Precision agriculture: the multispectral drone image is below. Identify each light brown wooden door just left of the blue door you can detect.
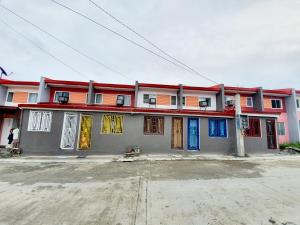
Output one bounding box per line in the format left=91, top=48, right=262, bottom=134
left=172, top=117, right=183, bottom=149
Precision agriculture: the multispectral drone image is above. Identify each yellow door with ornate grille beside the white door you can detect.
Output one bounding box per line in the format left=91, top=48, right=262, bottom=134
left=78, top=115, right=93, bottom=150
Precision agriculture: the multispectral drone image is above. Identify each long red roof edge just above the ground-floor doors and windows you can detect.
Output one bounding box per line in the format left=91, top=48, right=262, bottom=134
left=19, top=103, right=234, bottom=117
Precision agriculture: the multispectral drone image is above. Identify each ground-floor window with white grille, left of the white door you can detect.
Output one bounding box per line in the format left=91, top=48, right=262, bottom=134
left=28, top=111, right=52, bottom=132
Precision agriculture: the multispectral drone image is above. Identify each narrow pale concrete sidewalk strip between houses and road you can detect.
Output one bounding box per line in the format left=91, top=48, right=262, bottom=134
left=0, top=153, right=300, bottom=163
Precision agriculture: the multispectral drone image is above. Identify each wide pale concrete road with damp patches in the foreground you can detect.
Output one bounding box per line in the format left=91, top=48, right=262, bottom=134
left=0, top=159, right=300, bottom=225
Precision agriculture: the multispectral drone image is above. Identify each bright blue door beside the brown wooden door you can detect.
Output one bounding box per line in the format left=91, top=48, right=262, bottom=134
left=188, top=118, right=199, bottom=150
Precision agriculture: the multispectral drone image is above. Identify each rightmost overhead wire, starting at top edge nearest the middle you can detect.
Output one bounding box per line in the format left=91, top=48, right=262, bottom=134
left=88, top=0, right=217, bottom=84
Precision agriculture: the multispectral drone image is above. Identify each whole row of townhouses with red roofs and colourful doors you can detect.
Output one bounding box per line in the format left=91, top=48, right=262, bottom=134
left=0, top=77, right=300, bottom=155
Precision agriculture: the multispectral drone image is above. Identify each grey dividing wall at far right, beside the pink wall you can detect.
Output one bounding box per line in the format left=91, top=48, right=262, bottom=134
left=286, top=89, right=300, bottom=142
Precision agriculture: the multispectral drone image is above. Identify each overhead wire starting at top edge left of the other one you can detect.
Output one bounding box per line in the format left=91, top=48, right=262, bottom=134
left=50, top=0, right=217, bottom=83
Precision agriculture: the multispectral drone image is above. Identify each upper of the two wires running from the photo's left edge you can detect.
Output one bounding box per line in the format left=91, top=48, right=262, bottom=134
left=0, top=4, right=130, bottom=80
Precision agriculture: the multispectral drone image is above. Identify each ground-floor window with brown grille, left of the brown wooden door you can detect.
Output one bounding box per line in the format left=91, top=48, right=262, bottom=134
left=144, top=116, right=164, bottom=135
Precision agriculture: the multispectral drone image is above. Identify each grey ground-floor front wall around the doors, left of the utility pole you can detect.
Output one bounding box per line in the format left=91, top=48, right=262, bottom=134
left=21, top=110, right=235, bottom=155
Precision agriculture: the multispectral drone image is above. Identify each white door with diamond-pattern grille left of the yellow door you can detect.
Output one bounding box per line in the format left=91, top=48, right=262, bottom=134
left=60, top=113, right=78, bottom=149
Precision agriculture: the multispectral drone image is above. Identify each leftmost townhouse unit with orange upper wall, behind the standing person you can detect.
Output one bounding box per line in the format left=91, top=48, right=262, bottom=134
left=0, top=79, right=39, bottom=146
